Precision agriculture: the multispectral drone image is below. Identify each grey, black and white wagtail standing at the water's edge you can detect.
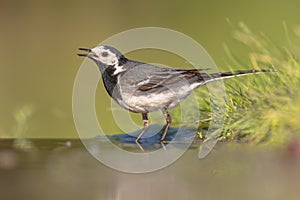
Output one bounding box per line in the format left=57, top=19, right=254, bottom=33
left=78, top=46, right=271, bottom=143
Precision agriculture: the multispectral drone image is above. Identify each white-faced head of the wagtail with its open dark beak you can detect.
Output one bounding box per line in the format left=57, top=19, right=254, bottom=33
left=77, top=46, right=125, bottom=66
